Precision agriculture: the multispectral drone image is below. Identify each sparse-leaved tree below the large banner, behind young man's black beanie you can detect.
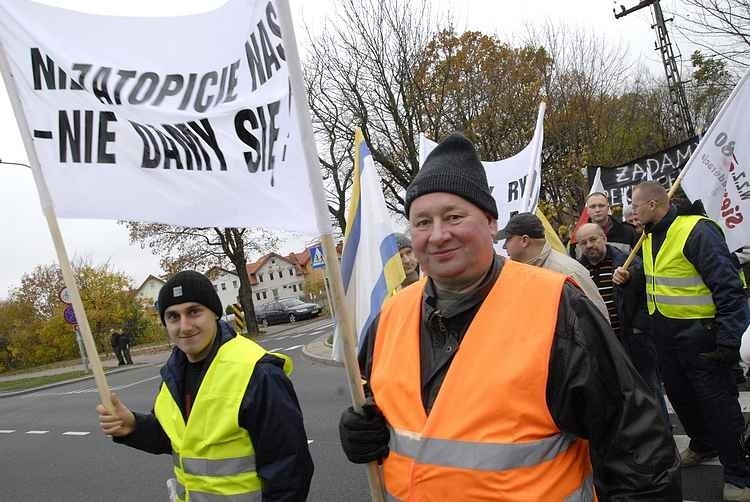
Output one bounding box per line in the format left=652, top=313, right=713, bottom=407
left=124, top=222, right=278, bottom=335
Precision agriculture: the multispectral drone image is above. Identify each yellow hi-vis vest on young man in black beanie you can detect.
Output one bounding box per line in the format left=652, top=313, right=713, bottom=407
left=154, top=334, right=292, bottom=502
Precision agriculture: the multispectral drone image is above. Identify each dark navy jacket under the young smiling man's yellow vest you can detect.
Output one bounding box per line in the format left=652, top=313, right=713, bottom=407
left=113, top=321, right=313, bottom=502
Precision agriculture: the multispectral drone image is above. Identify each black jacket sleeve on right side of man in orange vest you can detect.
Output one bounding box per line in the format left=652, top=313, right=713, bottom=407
left=547, top=285, right=682, bottom=502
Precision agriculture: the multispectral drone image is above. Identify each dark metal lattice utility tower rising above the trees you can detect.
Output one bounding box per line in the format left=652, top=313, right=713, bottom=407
left=614, top=0, right=695, bottom=137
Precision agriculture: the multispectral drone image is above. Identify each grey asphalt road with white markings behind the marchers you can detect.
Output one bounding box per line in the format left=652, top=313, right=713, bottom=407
left=0, top=320, right=750, bottom=502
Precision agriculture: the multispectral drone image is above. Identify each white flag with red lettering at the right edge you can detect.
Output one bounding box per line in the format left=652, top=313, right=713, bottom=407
left=682, top=68, right=750, bottom=251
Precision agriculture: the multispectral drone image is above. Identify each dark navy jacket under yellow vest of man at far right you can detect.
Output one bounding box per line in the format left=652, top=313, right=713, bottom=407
left=645, top=204, right=750, bottom=347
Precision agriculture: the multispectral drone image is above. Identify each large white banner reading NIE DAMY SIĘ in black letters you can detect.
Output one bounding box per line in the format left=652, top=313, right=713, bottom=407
left=0, top=0, right=318, bottom=233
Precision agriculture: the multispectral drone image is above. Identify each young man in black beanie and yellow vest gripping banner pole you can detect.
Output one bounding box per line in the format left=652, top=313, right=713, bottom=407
left=97, top=271, right=313, bottom=502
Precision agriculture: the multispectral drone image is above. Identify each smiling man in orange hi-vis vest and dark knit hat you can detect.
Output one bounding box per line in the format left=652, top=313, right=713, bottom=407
left=339, top=134, right=682, bottom=502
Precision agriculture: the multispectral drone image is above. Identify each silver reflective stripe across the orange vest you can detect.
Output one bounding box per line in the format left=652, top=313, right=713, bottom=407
left=389, top=429, right=575, bottom=471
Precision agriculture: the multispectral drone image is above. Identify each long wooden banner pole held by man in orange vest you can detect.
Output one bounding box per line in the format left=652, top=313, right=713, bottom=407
left=276, top=0, right=384, bottom=502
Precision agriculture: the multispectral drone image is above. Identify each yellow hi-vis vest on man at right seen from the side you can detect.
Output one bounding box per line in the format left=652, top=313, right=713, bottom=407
left=643, top=215, right=716, bottom=319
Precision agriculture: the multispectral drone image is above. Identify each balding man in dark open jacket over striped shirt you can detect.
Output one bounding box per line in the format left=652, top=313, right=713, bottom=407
left=576, top=223, right=669, bottom=423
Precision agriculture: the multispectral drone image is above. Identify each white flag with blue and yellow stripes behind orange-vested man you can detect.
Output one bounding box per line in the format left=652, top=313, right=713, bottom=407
left=334, top=128, right=406, bottom=355
